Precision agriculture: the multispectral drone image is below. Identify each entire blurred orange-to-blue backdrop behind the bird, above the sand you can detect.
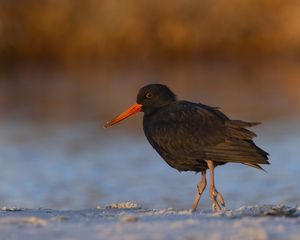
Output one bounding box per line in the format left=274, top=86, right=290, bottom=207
left=0, top=0, right=300, bottom=209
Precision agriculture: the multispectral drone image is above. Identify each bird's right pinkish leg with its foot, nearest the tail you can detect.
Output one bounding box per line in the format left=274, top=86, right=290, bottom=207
left=206, top=160, right=225, bottom=211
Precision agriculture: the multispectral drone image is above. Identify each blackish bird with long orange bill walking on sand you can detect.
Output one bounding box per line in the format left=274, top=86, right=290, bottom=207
left=104, top=84, right=270, bottom=211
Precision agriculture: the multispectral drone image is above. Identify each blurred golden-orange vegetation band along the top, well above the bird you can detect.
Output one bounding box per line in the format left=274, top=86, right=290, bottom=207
left=0, top=0, right=300, bottom=64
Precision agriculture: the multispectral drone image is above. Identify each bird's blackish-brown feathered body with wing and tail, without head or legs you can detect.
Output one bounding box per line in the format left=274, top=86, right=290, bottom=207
left=143, top=101, right=269, bottom=172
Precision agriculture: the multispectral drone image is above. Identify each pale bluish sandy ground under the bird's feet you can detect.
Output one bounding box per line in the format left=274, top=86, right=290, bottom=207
left=0, top=202, right=300, bottom=240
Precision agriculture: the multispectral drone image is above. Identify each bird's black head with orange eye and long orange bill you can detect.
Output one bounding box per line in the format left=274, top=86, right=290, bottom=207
left=104, top=84, right=176, bottom=128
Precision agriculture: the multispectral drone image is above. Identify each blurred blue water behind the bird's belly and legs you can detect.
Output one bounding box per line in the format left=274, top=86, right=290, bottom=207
left=0, top=121, right=300, bottom=209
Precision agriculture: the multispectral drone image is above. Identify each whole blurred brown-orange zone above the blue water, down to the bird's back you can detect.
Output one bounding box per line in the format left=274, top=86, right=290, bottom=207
left=0, top=0, right=300, bottom=120
